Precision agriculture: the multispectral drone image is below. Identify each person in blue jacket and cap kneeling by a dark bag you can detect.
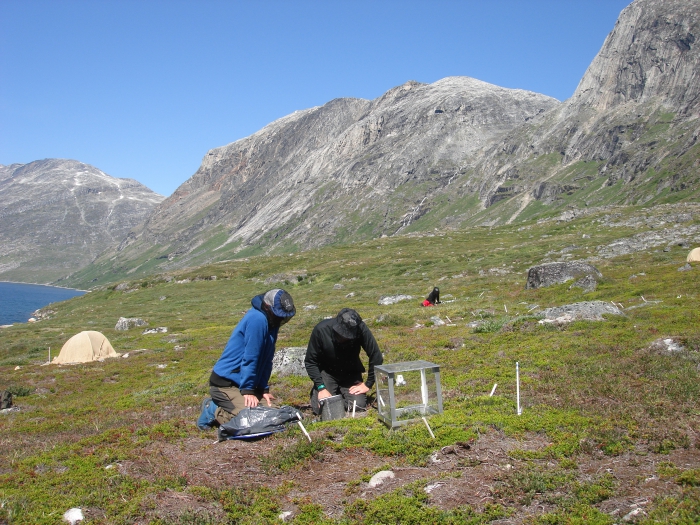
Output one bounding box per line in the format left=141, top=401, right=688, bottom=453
left=197, top=288, right=296, bottom=430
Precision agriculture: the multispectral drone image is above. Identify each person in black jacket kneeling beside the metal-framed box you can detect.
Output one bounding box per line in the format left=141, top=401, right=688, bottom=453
left=304, top=308, right=384, bottom=415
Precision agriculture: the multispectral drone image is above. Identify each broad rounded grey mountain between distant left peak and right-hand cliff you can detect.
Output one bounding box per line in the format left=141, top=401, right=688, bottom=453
left=115, top=77, right=558, bottom=265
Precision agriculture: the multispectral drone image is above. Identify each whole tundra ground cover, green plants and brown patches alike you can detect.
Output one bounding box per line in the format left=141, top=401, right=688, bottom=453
left=0, top=208, right=700, bottom=525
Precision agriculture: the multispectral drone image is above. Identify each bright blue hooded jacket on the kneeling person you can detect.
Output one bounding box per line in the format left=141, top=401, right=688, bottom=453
left=214, top=294, right=279, bottom=395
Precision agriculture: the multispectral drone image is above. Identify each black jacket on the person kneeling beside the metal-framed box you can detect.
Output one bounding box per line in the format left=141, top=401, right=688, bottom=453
left=304, top=319, right=384, bottom=388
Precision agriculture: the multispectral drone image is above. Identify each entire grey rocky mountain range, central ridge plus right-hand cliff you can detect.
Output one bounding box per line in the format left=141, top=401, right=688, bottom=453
left=71, top=0, right=700, bottom=279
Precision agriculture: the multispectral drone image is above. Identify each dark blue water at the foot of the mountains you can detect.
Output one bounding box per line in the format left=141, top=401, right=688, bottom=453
left=0, top=282, right=85, bottom=325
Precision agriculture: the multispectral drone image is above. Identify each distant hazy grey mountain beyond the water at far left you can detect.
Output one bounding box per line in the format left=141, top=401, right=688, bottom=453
left=0, top=159, right=163, bottom=283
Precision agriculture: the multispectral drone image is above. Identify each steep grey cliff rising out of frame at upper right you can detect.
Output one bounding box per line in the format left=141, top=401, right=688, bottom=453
left=463, top=0, right=700, bottom=223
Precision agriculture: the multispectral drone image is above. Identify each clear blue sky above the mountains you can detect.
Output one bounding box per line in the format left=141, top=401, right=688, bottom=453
left=0, top=0, right=629, bottom=196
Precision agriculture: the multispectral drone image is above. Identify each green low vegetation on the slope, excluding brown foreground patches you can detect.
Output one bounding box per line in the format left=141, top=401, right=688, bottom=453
left=0, top=204, right=700, bottom=524
